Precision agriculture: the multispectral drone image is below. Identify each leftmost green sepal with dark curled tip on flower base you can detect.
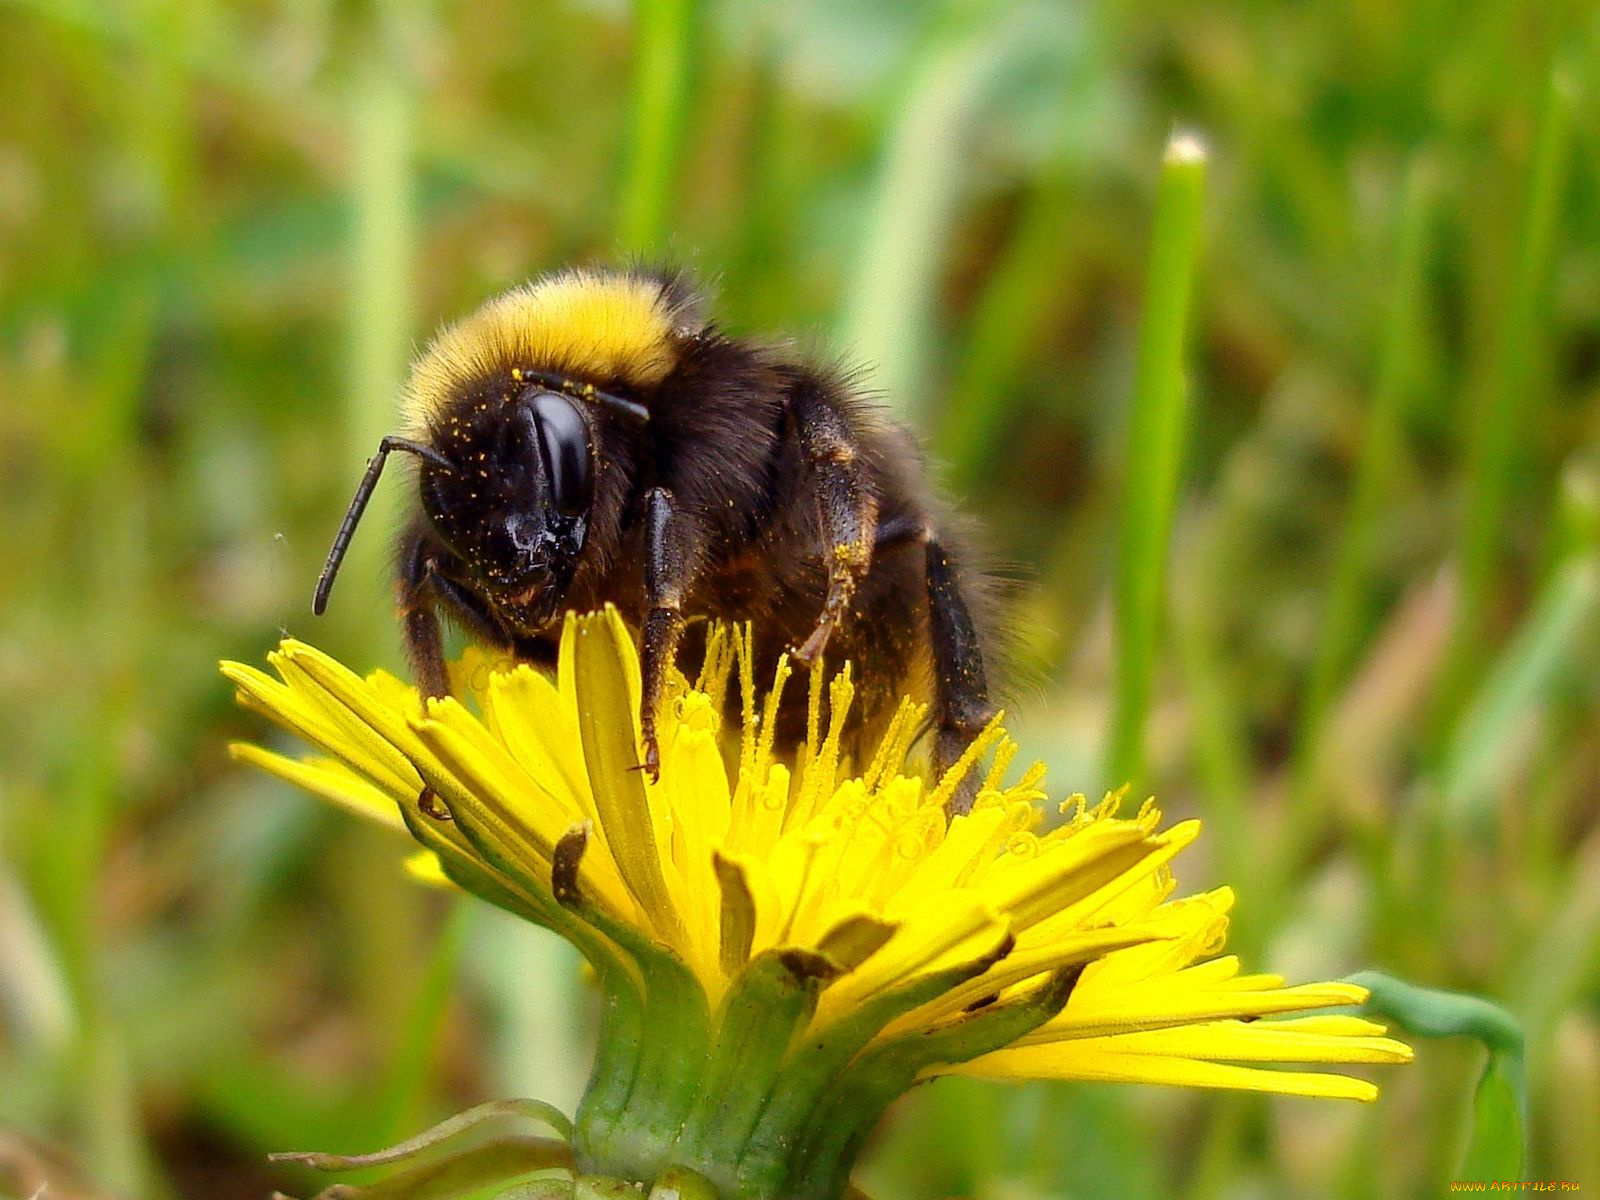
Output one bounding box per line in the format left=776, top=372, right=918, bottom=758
left=550, top=827, right=710, bottom=1179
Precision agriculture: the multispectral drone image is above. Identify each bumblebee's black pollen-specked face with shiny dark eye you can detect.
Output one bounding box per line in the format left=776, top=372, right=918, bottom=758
left=418, top=382, right=595, bottom=634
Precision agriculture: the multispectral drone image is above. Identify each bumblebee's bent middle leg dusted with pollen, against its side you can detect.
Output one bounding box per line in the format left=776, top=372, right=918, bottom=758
left=790, top=384, right=878, bottom=666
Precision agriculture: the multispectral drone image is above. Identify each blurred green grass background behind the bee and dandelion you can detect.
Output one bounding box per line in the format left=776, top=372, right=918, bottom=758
left=0, top=0, right=1600, bottom=1200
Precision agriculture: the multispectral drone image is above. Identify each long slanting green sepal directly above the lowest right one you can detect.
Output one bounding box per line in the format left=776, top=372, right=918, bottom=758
left=738, top=934, right=1014, bottom=1194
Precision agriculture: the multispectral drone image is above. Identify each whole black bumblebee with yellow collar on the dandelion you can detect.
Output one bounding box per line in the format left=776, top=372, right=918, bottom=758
left=312, top=270, right=994, bottom=808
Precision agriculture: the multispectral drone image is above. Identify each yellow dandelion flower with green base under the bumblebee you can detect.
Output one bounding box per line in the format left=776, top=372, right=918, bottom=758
left=224, top=610, right=1410, bottom=1200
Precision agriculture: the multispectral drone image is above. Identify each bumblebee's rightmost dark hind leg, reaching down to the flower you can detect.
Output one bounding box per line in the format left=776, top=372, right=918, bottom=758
left=926, top=536, right=995, bottom=816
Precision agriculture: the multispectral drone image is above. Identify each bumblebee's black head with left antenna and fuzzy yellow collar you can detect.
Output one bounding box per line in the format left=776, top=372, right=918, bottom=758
left=312, top=270, right=681, bottom=634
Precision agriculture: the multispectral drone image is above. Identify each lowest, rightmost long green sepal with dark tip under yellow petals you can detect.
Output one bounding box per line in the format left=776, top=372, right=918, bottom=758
left=781, top=965, right=1083, bottom=1200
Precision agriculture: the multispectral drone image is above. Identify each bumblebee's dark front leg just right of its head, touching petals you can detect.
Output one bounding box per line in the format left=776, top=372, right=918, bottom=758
left=638, top=488, right=706, bottom=779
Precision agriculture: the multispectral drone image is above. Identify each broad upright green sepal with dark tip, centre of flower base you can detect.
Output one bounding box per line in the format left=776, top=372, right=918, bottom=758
left=678, top=949, right=840, bottom=1182
